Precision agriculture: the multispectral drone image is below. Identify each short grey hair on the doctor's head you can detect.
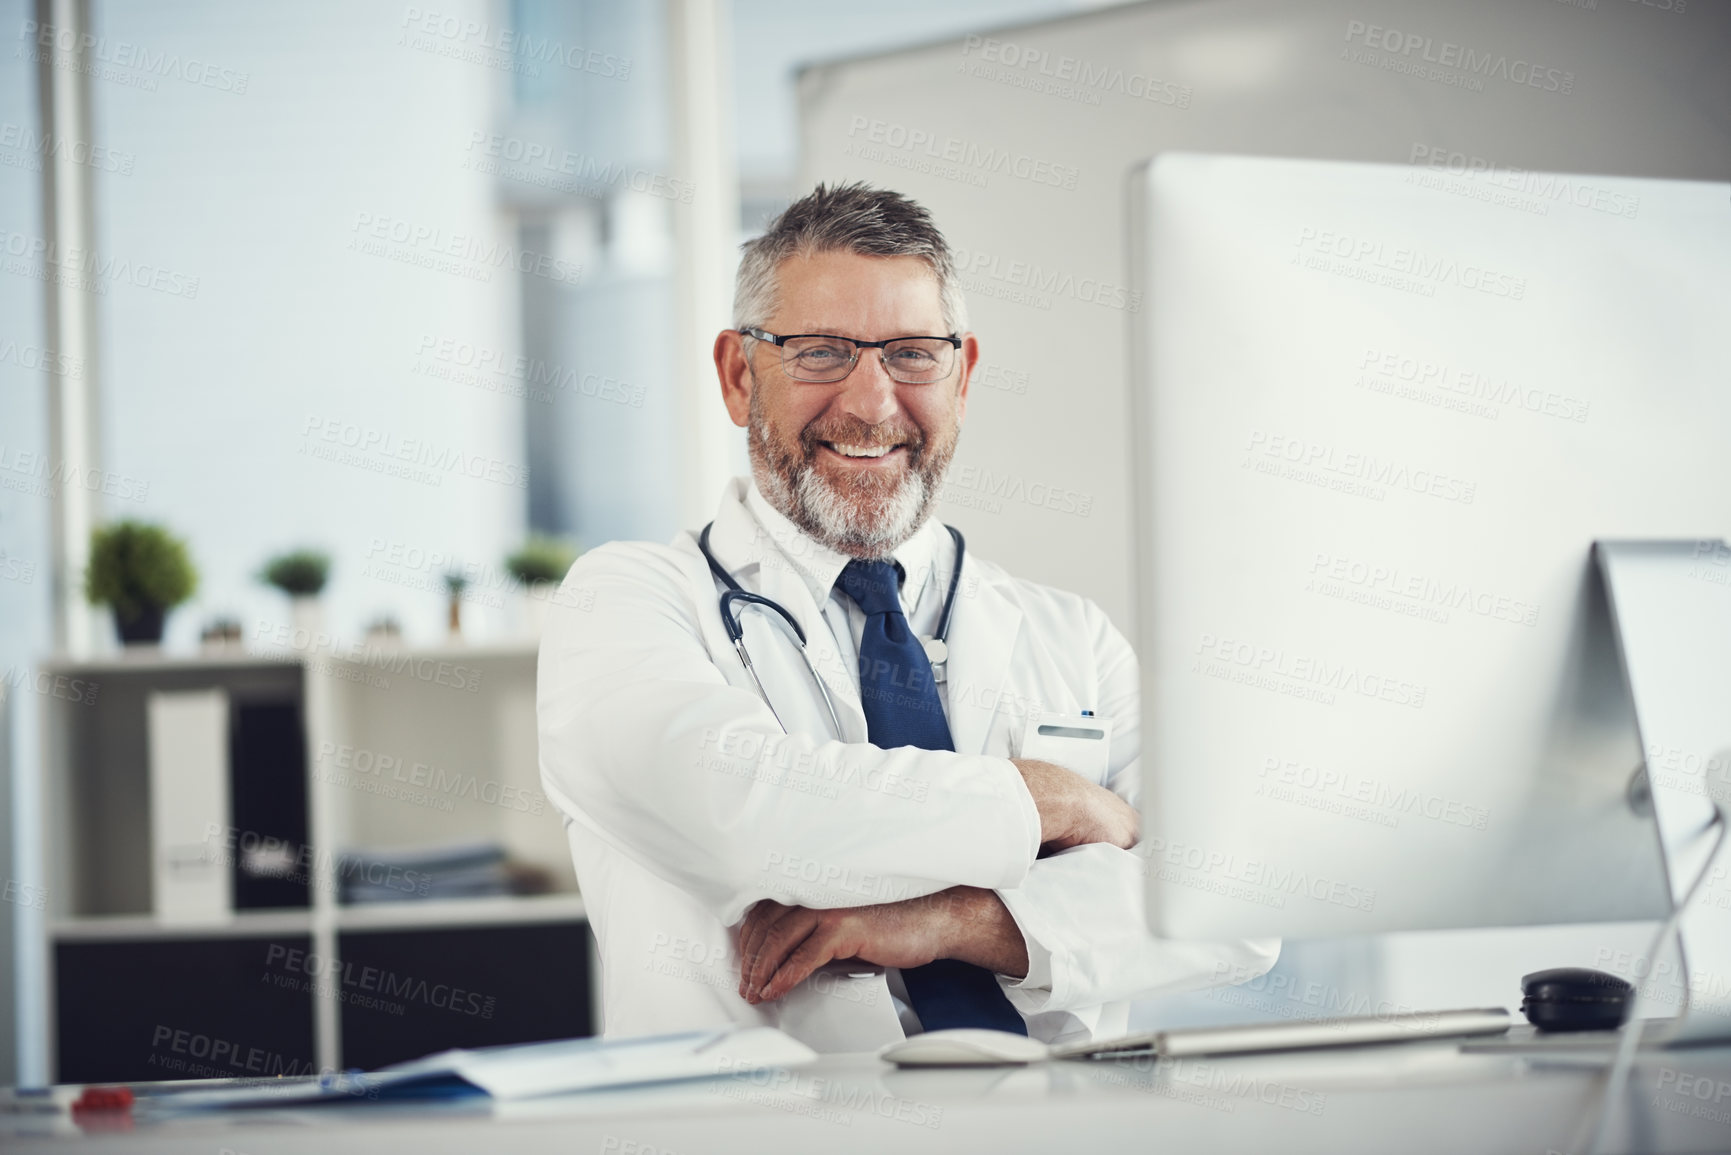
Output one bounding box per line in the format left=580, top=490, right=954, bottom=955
left=734, top=182, right=968, bottom=336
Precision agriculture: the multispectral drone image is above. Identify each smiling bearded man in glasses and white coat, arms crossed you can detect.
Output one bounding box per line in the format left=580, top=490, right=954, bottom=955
left=538, top=185, right=1277, bottom=1051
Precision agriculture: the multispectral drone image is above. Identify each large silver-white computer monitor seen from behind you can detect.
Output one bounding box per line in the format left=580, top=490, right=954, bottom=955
left=1130, top=154, right=1731, bottom=939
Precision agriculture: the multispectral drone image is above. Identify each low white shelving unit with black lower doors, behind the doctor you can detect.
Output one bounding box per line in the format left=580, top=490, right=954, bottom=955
left=28, top=641, right=592, bottom=1070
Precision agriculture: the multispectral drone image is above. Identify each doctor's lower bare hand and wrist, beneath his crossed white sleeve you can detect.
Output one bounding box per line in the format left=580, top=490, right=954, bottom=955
left=739, top=893, right=1024, bottom=1004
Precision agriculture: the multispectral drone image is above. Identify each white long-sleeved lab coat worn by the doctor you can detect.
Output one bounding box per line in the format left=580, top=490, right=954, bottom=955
left=537, top=478, right=1277, bottom=1051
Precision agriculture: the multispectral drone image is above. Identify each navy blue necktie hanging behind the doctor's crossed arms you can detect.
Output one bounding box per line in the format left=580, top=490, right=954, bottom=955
left=836, top=561, right=1028, bottom=1036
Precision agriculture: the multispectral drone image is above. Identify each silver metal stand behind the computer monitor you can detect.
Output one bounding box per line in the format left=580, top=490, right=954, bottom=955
left=1593, top=540, right=1731, bottom=1044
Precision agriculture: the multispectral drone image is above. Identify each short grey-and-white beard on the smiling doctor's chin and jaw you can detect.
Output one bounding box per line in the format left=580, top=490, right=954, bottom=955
left=748, top=379, right=956, bottom=561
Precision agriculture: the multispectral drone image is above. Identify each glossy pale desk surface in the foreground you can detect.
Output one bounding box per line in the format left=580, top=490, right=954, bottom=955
left=0, top=1042, right=1731, bottom=1155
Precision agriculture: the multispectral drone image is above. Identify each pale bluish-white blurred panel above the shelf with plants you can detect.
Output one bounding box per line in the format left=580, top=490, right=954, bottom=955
left=93, top=0, right=526, bottom=648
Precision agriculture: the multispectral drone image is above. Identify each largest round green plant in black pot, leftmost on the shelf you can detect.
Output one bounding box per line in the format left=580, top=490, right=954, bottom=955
left=85, top=521, right=199, bottom=646
